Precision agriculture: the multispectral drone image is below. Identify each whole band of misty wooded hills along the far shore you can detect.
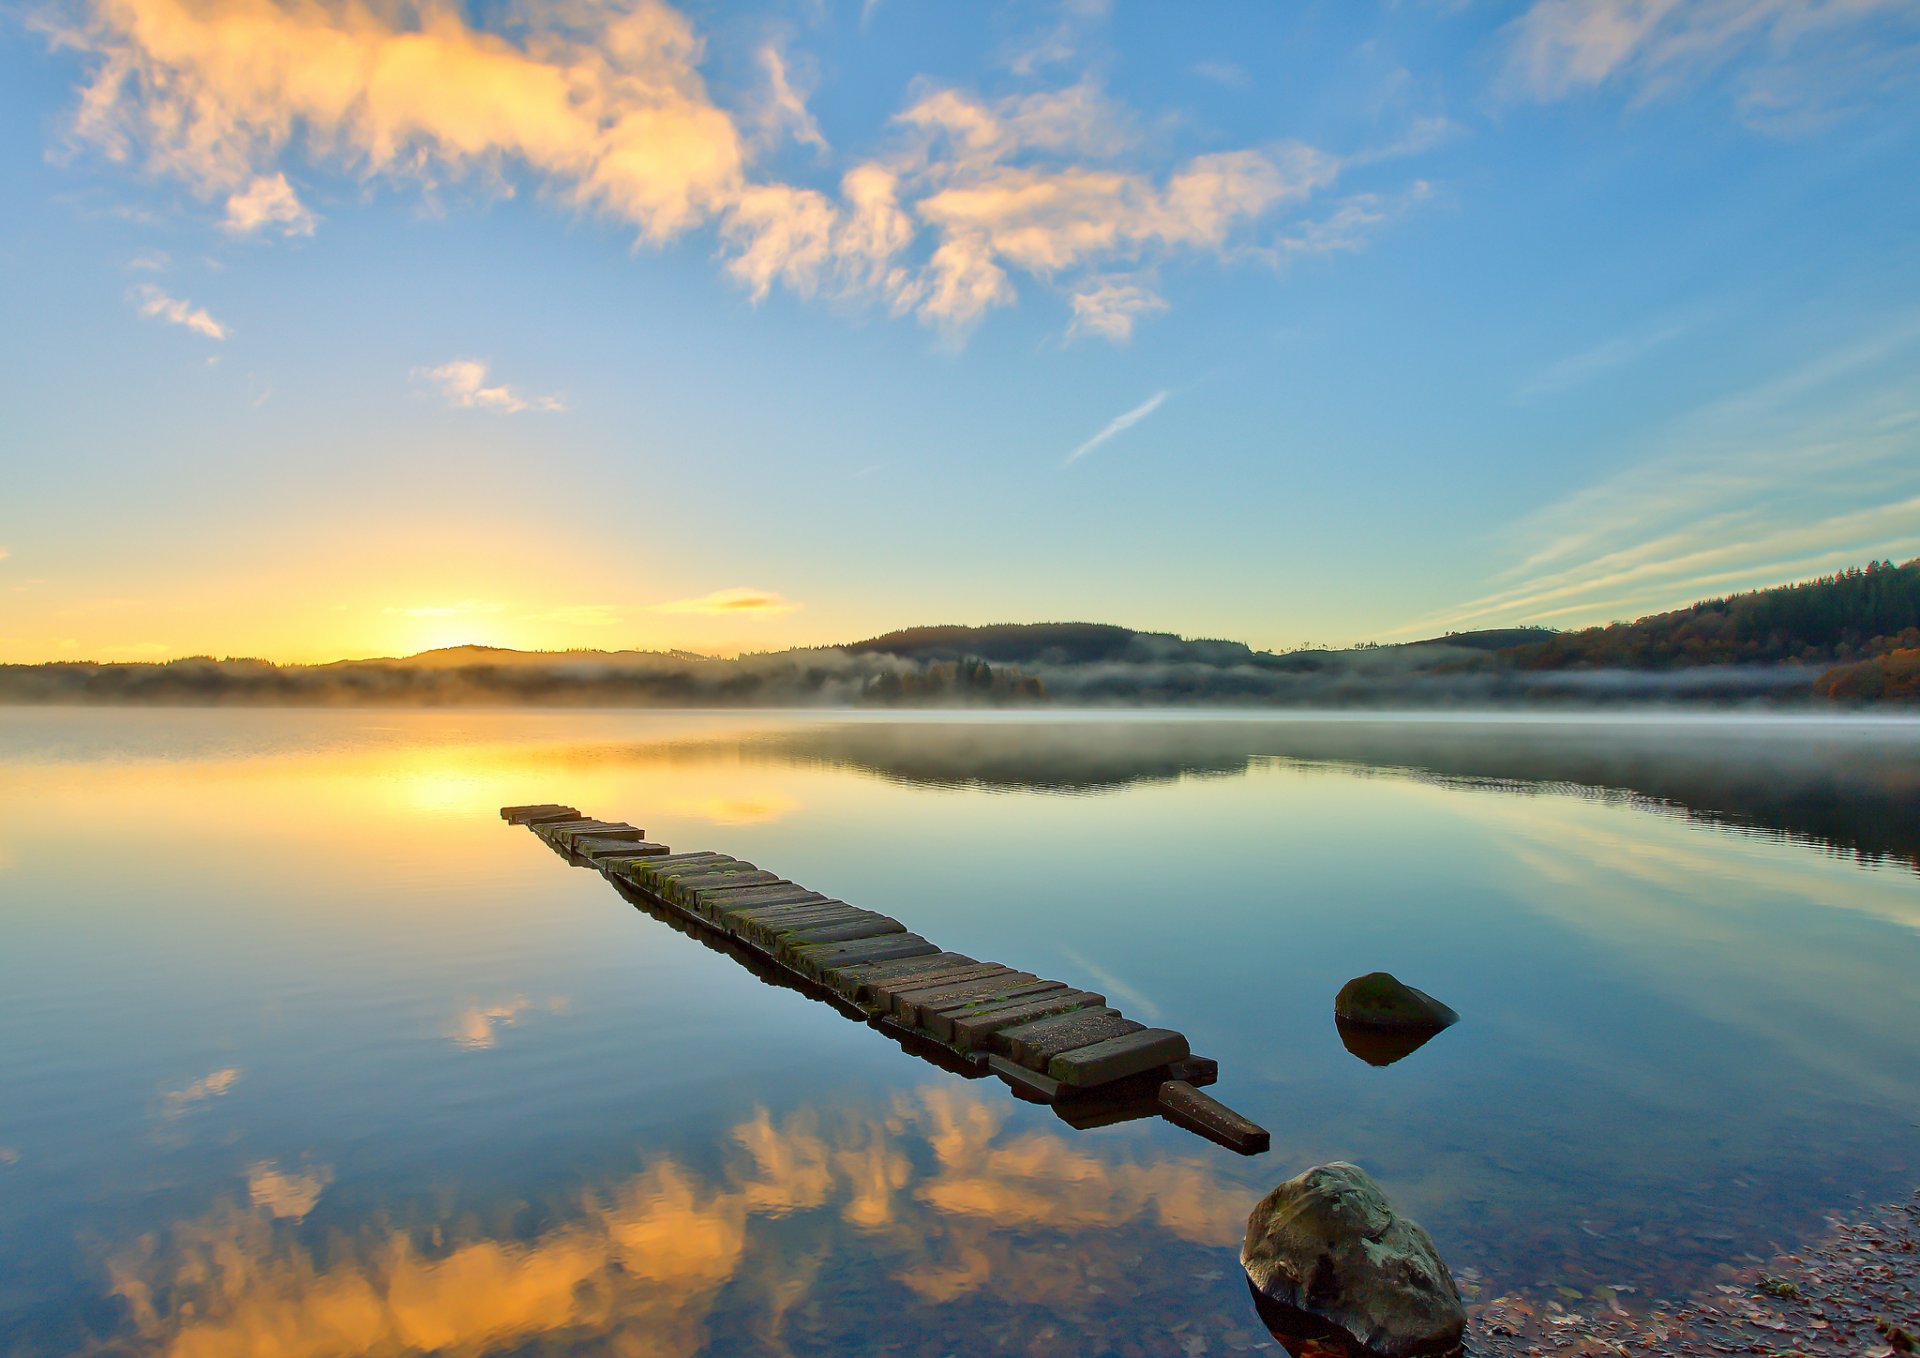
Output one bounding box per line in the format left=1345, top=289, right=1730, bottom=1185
left=0, top=561, right=1920, bottom=707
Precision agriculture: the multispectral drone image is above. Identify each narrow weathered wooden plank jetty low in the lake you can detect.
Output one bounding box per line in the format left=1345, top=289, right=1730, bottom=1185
left=499, top=805, right=1269, bottom=1154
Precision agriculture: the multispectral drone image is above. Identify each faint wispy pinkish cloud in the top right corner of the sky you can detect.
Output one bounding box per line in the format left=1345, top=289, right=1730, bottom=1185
left=1503, top=0, right=1920, bottom=125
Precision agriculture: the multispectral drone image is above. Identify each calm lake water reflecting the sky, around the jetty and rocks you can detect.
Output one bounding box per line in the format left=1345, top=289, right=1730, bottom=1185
left=0, top=711, right=1920, bottom=1358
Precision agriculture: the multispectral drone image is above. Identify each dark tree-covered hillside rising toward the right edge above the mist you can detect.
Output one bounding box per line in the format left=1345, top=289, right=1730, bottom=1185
left=1500, top=559, right=1920, bottom=670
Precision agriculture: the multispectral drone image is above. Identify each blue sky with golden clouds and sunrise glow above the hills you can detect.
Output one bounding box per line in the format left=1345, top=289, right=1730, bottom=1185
left=0, top=0, right=1920, bottom=661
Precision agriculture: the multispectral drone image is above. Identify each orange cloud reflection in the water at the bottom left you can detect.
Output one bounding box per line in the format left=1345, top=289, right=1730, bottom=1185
left=111, top=1087, right=1252, bottom=1358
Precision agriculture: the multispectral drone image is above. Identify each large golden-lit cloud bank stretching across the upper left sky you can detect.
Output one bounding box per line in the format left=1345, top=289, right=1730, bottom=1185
left=56, top=0, right=1413, bottom=339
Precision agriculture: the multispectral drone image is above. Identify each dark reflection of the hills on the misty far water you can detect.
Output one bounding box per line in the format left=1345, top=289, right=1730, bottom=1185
left=737, top=716, right=1920, bottom=866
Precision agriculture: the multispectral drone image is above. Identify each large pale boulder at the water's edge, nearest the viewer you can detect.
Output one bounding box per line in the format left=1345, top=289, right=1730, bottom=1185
left=1240, top=1162, right=1467, bottom=1358
